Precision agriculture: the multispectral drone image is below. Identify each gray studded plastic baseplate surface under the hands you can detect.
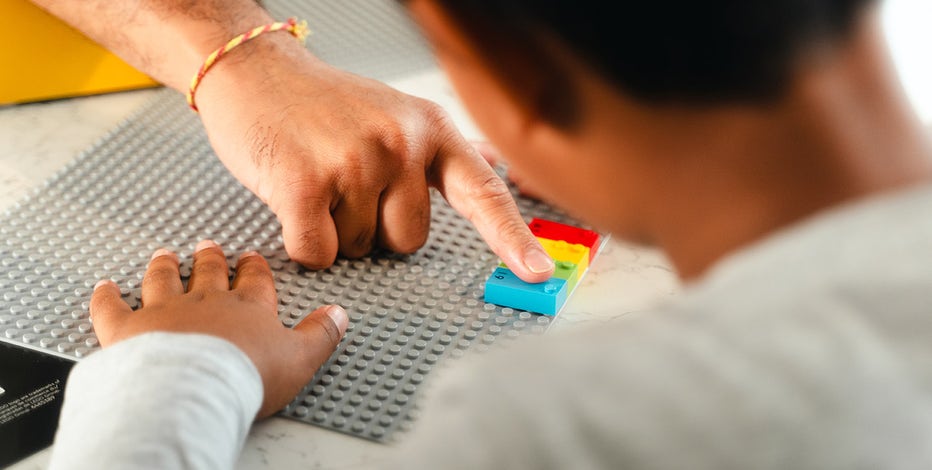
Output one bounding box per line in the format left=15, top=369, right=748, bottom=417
left=0, top=1, right=596, bottom=441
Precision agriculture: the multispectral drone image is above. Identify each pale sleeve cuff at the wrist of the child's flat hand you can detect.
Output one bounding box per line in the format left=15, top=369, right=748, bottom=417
left=49, top=333, right=263, bottom=470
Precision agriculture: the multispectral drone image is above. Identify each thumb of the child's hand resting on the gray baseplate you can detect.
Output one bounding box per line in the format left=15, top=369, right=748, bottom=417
left=294, top=305, right=349, bottom=370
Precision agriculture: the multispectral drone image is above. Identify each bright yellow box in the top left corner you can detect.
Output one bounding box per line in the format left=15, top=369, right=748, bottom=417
left=0, top=0, right=158, bottom=105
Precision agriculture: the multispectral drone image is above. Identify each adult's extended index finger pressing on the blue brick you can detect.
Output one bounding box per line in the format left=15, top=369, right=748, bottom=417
left=431, top=136, right=554, bottom=282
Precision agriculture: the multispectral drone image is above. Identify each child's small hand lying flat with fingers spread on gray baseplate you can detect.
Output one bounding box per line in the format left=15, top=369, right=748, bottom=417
left=90, top=241, right=349, bottom=417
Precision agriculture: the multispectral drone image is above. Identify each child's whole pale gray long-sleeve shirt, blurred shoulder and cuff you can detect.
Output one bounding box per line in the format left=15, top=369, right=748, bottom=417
left=52, top=187, right=932, bottom=469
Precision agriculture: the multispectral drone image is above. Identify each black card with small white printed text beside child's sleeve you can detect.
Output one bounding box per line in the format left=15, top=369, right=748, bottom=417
left=0, top=342, right=75, bottom=467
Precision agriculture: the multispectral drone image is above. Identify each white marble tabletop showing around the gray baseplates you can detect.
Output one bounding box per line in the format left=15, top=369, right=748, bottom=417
left=0, top=72, right=679, bottom=470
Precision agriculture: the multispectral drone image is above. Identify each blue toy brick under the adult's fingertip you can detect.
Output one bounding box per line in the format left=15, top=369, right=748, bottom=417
left=485, top=267, right=569, bottom=315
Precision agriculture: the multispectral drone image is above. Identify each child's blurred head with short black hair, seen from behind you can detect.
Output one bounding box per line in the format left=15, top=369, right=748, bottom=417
left=407, top=0, right=912, bottom=278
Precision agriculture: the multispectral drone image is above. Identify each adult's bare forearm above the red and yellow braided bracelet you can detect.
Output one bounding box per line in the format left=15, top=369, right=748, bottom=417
left=33, top=0, right=274, bottom=91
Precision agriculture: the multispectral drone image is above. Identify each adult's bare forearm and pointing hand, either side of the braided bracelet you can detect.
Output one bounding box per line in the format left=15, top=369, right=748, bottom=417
left=27, top=0, right=553, bottom=282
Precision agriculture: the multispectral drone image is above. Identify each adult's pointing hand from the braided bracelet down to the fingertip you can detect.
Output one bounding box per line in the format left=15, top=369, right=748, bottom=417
left=197, top=34, right=553, bottom=282
